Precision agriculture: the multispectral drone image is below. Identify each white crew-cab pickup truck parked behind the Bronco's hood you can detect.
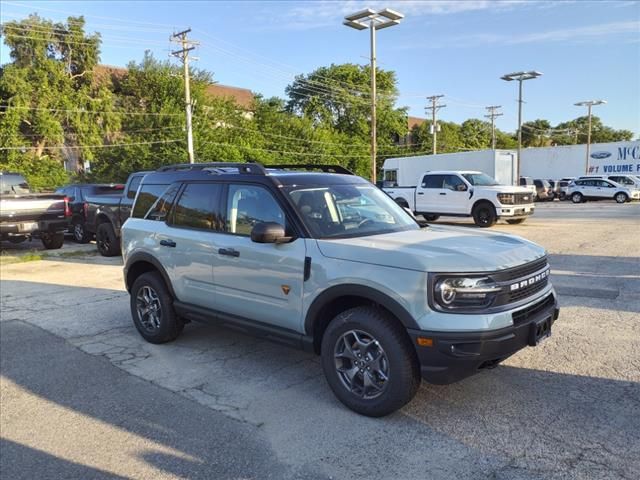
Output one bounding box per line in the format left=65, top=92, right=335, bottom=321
left=383, top=171, right=535, bottom=227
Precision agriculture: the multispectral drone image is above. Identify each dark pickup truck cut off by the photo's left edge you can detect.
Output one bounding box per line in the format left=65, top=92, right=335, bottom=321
left=0, top=172, right=71, bottom=249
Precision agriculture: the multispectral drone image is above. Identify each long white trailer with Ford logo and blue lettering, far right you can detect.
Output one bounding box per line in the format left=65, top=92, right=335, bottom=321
left=520, top=141, right=640, bottom=179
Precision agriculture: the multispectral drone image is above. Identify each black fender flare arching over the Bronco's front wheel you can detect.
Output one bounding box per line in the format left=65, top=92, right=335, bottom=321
left=304, top=284, right=420, bottom=335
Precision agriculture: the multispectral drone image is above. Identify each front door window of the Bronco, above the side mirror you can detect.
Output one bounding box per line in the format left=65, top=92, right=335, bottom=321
left=226, top=185, right=289, bottom=236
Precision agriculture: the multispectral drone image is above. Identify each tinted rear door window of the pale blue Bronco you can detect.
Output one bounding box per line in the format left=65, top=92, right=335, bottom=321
left=170, top=183, right=224, bottom=230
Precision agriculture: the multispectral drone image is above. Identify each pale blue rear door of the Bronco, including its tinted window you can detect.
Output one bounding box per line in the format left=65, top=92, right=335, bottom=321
left=156, top=183, right=223, bottom=308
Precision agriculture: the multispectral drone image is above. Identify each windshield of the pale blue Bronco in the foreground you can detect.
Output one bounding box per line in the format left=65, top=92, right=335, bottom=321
left=288, top=185, right=420, bottom=238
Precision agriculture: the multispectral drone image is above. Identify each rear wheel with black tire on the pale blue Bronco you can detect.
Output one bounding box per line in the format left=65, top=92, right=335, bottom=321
left=129, top=272, right=184, bottom=343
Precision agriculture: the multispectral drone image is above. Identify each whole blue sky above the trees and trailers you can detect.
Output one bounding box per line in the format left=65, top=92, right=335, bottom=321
left=0, top=0, right=640, bottom=136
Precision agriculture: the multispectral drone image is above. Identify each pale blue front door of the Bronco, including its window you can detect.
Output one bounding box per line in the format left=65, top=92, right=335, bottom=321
left=213, top=184, right=306, bottom=331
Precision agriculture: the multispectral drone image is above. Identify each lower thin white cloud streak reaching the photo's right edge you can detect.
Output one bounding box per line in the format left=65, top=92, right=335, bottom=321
left=400, top=21, right=640, bottom=50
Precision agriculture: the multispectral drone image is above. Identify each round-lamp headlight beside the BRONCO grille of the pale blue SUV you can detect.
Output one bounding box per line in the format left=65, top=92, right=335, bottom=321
left=432, top=275, right=501, bottom=310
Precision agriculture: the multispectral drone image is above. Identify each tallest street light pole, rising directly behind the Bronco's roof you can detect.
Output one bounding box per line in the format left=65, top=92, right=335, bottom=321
left=342, top=8, right=404, bottom=183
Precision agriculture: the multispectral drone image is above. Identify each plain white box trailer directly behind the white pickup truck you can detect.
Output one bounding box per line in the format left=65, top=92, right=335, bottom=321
left=382, top=150, right=518, bottom=187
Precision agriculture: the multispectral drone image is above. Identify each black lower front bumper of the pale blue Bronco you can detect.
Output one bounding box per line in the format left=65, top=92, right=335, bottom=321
left=408, top=293, right=560, bottom=385
